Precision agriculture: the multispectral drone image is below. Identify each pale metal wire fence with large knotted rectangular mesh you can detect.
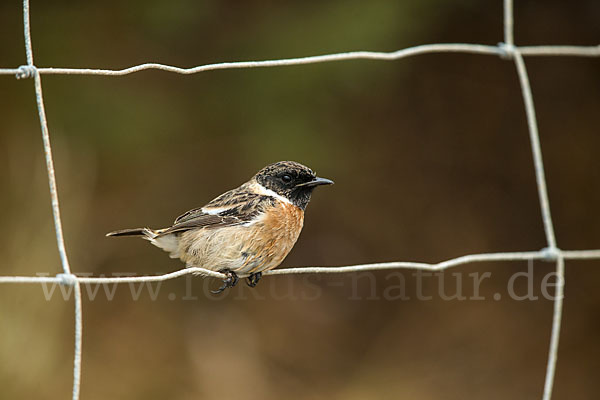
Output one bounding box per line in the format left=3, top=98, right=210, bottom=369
left=0, top=0, right=600, bottom=400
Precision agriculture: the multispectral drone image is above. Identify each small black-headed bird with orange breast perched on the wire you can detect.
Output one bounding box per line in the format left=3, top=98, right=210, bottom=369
left=106, top=161, right=333, bottom=293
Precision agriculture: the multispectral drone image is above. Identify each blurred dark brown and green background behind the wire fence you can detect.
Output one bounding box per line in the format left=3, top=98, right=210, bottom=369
left=0, top=0, right=600, bottom=400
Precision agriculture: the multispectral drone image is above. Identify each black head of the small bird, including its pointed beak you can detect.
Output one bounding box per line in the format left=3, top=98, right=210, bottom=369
left=255, top=161, right=333, bottom=210
